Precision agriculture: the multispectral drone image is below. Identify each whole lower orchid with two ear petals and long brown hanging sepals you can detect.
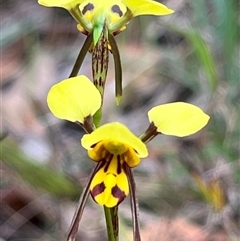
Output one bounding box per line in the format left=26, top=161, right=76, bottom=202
left=47, top=76, right=209, bottom=240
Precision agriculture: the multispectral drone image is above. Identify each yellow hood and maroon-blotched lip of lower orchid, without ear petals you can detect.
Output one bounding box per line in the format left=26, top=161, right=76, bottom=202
left=81, top=122, right=148, bottom=207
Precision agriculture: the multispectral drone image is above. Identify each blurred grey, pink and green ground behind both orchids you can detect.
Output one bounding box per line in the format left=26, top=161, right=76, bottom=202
left=0, top=0, right=240, bottom=241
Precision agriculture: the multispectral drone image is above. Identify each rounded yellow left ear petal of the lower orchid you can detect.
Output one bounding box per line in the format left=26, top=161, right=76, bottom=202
left=47, top=75, right=101, bottom=123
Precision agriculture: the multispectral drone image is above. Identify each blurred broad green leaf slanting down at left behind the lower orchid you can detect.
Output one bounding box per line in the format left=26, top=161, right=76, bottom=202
left=0, top=138, right=82, bottom=199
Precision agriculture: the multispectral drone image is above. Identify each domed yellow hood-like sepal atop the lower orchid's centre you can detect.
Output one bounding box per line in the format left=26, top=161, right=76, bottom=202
left=81, top=122, right=148, bottom=158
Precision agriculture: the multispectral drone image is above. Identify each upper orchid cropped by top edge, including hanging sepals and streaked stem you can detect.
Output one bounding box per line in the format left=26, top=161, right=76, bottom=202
left=38, top=0, right=173, bottom=104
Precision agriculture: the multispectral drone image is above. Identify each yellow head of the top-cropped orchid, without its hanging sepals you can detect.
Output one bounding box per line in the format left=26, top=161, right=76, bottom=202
left=38, top=0, right=173, bottom=43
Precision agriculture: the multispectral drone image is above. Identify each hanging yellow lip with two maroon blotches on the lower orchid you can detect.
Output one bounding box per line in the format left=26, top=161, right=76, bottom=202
left=90, top=156, right=129, bottom=207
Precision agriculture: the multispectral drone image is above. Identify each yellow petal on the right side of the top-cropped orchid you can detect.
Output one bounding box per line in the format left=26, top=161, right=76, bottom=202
left=122, top=0, right=174, bottom=16
